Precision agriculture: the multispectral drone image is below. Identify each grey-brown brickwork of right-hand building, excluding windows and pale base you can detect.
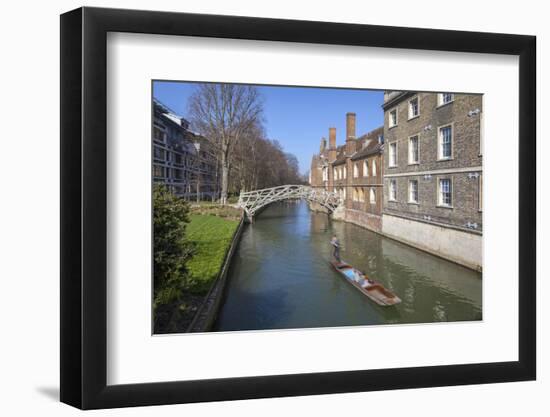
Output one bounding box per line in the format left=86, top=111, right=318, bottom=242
left=383, top=93, right=482, bottom=233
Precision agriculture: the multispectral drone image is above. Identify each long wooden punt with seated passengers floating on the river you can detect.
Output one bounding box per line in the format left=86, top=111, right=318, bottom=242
left=330, top=261, right=401, bottom=306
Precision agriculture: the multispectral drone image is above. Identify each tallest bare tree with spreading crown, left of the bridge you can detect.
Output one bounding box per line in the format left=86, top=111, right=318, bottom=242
left=189, top=84, right=263, bottom=204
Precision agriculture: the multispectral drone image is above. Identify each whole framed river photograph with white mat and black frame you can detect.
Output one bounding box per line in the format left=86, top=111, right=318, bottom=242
left=60, top=7, right=536, bottom=409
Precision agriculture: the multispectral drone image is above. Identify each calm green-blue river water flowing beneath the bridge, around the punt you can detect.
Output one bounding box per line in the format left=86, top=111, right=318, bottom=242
left=215, top=202, right=482, bottom=331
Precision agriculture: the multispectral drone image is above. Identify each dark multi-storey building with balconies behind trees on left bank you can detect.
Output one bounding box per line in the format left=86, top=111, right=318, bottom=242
left=152, top=100, right=220, bottom=200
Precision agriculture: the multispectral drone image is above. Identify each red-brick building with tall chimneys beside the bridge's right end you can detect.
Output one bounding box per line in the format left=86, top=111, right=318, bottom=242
left=310, top=113, right=384, bottom=232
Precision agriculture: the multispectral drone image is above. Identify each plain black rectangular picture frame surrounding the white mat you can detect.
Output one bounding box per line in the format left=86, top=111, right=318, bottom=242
left=60, top=7, right=536, bottom=409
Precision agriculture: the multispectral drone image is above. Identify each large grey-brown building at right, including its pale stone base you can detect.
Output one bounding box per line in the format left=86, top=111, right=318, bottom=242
left=382, top=91, right=483, bottom=270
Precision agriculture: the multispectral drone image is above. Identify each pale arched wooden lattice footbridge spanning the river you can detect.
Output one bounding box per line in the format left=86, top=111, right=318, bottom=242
left=238, top=185, right=341, bottom=219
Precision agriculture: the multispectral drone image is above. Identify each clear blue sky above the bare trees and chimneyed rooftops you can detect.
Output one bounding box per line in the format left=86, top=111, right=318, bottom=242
left=153, top=81, right=384, bottom=173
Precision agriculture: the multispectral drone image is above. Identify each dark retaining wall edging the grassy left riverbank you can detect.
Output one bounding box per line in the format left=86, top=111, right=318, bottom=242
left=187, top=213, right=246, bottom=333
